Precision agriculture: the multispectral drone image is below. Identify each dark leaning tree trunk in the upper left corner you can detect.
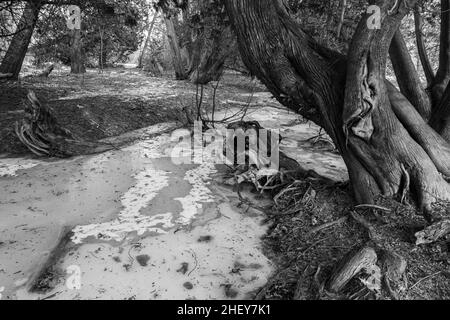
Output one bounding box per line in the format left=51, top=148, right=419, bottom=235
left=0, top=1, right=41, bottom=79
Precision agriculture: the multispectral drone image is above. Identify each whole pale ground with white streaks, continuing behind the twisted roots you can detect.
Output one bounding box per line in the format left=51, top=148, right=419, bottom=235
left=0, top=70, right=347, bottom=299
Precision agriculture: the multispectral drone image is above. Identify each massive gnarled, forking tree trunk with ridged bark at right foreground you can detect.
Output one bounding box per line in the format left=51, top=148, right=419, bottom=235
left=223, top=0, right=450, bottom=216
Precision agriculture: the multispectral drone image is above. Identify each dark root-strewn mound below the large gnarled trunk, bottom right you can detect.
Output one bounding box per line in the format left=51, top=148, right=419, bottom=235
left=261, top=172, right=450, bottom=300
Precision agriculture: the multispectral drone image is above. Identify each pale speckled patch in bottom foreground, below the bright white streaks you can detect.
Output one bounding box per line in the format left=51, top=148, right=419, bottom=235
left=17, top=201, right=273, bottom=300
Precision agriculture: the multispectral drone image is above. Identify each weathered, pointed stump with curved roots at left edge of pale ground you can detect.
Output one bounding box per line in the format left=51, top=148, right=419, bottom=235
left=15, top=91, right=115, bottom=158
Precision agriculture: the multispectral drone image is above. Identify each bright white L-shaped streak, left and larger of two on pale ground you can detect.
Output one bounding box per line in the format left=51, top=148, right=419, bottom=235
left=72, top=168, right=174, bottom=244
